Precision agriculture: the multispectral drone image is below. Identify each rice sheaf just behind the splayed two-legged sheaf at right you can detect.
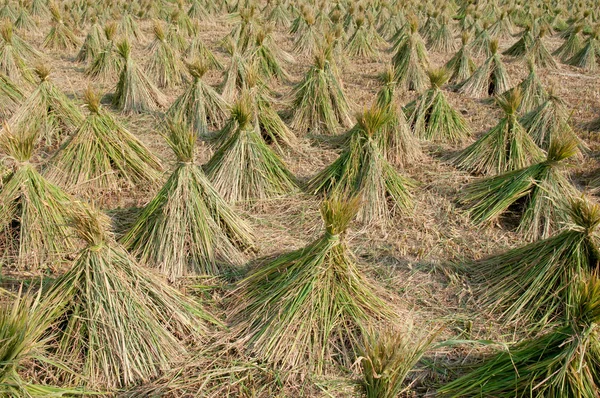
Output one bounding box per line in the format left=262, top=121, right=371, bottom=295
left=454, top=88, right=543, bottom=174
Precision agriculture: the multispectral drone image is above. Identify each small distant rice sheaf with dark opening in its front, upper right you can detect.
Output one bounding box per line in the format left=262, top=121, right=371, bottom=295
left=458, top=40, right=510, bottom=98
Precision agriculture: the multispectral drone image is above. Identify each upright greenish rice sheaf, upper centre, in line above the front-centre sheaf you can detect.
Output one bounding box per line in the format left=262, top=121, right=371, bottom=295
left=290, top=46, right=352, bottom=135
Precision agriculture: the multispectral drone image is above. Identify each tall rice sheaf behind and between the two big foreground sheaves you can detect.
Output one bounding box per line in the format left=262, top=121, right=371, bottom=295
left=121, top=123, right=252, bottom=280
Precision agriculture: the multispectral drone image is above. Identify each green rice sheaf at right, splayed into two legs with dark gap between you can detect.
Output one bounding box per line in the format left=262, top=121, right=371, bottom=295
left=461, top=135, right=577, bottom=240
